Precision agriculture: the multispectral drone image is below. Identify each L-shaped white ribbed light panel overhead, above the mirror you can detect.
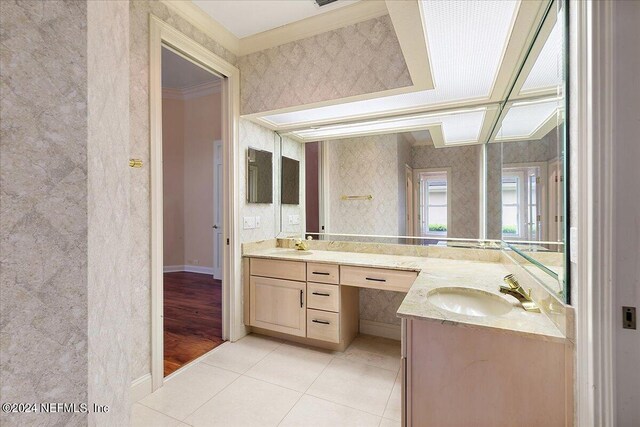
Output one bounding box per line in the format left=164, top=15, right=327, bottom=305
left=262, top=0, right=519, bottom=127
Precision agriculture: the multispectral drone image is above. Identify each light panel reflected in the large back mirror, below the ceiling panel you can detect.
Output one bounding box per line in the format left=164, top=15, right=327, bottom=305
left=293, top=108, right=486, bottom=145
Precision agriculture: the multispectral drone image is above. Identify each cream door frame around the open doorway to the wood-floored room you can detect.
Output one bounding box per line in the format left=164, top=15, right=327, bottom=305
left=149, top=15, right=245, bottom=390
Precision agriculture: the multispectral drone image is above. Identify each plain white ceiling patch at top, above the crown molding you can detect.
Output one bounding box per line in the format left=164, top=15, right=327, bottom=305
left=193, top=0, right=358, bottom=39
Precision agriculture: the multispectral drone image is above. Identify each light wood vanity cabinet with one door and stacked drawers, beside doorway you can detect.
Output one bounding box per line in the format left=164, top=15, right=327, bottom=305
left=243, top=258, right=360, bottom=351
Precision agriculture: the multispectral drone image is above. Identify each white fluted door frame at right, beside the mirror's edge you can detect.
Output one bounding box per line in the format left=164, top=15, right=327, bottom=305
left=565, top=1, right=618, bottom=426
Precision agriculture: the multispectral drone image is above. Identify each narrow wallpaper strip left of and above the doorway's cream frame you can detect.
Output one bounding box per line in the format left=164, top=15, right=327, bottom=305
left=129, top=0, right=236, bottom=380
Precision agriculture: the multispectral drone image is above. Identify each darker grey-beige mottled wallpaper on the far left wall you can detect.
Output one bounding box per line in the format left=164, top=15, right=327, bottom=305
left=0, top=0, right=90, bottom=427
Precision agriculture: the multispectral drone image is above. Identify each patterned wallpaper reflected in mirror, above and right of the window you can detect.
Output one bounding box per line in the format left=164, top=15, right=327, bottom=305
left=412, top=145, right=481, bottom=239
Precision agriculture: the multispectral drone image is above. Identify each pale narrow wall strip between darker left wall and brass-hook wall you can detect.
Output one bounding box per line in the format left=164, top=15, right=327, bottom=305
left=87, top=1, right=131, bottom=426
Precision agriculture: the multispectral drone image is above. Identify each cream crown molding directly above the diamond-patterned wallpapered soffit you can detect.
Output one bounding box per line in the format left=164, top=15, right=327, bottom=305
left=240, top=0, right=388, bottom=56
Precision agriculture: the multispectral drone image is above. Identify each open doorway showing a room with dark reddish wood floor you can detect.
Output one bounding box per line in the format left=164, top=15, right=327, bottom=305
left=161, top=46, right=224, bottom=377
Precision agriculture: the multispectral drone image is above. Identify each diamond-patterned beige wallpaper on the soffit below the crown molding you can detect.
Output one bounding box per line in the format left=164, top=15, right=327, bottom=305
left=238, top=15, right=412, bottom=114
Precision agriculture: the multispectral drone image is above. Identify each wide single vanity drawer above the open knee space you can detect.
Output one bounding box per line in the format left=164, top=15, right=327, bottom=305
left=340, top=265, right=418, bottom=292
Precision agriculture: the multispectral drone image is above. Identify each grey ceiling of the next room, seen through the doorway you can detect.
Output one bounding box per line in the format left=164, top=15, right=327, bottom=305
left=162, top=48, right=220, bottom=90
